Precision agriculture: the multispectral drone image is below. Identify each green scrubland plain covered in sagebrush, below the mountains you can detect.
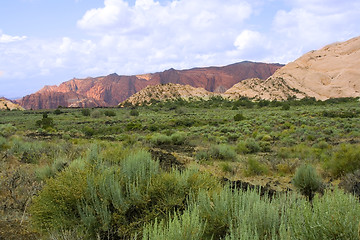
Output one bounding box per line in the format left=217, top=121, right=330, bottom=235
left=0, top=97, right=360, bottom=240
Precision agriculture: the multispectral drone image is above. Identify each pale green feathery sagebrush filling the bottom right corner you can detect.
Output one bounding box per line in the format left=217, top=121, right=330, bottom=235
left=286, top=188, right=360, bottom=240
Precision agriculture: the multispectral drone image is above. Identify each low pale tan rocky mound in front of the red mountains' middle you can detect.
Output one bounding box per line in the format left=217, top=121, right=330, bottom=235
left=120, top=83, right=218, bottom=106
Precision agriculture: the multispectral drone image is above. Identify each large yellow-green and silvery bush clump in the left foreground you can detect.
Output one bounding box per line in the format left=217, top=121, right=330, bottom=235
left=31, top=149, right=220, bottom=239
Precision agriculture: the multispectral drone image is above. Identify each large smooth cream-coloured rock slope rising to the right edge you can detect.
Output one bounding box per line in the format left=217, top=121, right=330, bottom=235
left=225, top=37, right=360, bottom=100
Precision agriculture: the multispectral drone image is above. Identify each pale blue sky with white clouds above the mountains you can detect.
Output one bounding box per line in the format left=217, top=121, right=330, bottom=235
left=0, top=0, right=360, bottom=99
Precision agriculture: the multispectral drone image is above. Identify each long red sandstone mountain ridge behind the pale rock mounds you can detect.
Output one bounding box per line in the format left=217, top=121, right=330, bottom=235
left=17, top=62, right=282, bottom=109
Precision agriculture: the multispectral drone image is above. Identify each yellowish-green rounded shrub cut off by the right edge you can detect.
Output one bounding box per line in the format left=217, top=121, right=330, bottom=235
left=325, top=144, right=360, bottom=177
